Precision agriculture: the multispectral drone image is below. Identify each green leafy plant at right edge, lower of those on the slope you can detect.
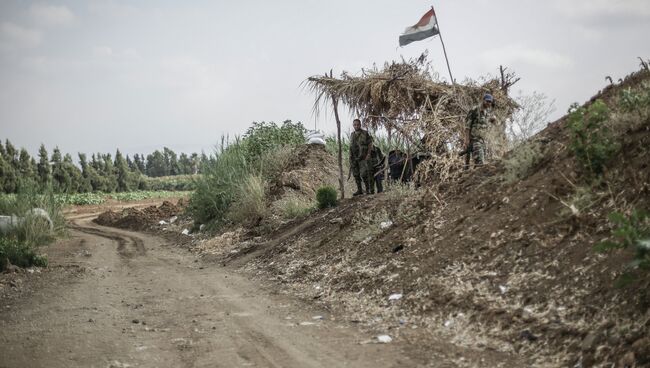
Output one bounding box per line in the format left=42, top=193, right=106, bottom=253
left=595, top=210, right=650, bottom=271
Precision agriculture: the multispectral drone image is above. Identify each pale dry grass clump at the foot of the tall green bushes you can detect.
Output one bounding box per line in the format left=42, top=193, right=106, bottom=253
left=228, top=175, right=267, bottom=226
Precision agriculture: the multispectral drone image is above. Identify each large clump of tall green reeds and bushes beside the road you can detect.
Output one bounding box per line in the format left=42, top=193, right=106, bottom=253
left=188, top=120, right=305, bottom=226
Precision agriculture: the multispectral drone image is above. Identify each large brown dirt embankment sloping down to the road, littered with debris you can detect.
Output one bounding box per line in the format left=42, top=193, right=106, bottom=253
left=224, top=68, right=650, bottom=367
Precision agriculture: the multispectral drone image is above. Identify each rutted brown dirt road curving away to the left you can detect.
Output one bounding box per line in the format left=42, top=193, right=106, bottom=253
left=0, top=208, right=426, bottom=367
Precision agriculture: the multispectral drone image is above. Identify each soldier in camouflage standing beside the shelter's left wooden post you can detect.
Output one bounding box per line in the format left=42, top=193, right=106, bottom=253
left=350, top=119, right=375, bottom=196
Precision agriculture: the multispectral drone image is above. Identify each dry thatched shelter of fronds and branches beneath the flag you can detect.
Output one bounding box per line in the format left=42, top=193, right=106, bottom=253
left=306, top=55, right=517, bottom=193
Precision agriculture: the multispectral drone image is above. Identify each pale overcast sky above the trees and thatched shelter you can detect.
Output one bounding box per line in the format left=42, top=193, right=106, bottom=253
left=0, top=0, right=650, bottom=157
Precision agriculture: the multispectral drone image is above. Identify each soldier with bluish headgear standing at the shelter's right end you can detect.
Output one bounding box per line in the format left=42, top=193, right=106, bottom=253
left=465, top=93, right=496, bottom=166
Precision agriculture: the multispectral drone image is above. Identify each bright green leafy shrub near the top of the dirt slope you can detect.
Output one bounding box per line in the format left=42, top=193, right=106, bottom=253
left=568, top=100, right=618, bottom=177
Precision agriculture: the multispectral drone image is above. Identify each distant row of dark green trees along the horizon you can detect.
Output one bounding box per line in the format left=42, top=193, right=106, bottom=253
left=0, top=140, right=213, bottom=193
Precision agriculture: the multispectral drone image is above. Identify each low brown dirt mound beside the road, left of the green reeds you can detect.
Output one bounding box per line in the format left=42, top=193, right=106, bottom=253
left=93, top=200, right=184, bottom=230
